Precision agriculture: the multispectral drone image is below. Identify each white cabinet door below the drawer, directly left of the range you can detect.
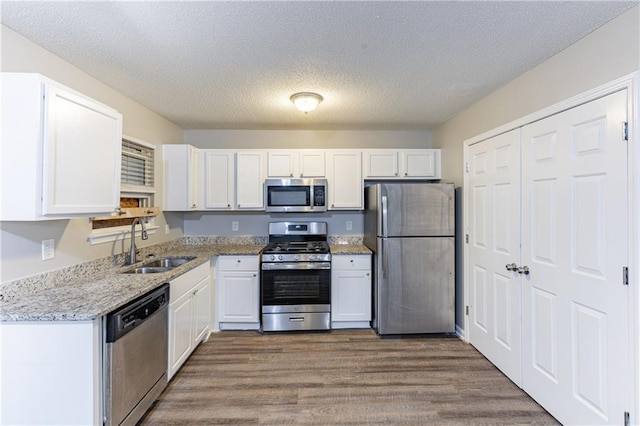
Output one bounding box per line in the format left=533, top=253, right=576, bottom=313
left=218, top=271, right=260, bottom=323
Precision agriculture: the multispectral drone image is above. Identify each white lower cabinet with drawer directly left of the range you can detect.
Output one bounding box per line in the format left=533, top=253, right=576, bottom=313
left=216, top=256, right=260, bottom=330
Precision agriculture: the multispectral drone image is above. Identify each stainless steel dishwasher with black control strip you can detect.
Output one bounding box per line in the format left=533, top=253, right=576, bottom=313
left=104, top=284, right=169, bottom=425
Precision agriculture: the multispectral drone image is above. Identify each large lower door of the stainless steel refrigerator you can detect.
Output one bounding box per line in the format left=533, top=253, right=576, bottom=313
left=374, top=237, right=455, bottom=335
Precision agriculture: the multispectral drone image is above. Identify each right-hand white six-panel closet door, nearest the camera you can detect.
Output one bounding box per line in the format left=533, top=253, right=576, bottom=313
left=520, top=92, right=633, bottom=424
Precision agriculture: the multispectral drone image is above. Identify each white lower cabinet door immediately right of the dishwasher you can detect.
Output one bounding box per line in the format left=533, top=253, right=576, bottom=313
left=168, top=293, right=194, bottom=378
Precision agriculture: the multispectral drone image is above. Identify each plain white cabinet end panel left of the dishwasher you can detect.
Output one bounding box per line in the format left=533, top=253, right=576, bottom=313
left=0, top=317, right=103, bottom=425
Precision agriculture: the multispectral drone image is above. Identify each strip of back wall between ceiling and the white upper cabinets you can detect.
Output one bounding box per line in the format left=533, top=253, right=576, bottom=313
left=184, top=130, right=431, bottom=149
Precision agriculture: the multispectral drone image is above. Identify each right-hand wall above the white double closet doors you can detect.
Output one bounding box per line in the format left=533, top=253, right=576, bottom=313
left=433, top=6, right=640, bottom=185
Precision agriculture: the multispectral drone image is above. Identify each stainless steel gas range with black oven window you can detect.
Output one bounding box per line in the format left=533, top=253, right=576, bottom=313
left=260, top=222, right=331, bottom=331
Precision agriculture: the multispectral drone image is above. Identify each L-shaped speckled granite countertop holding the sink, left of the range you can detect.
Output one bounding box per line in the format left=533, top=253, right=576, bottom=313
left=0, top=244, right=264, bottom=322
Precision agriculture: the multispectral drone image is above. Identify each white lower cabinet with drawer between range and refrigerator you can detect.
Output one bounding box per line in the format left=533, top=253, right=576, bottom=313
left=331, top=255, right=372, bottom=328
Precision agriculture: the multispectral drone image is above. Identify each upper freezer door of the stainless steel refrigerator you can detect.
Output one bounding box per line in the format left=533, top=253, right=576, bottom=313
left=376, top=183, right=455, bottom=237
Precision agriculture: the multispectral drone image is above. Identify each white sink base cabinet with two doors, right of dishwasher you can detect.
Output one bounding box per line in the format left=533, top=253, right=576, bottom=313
left=167, top=263, right=211, bottom=379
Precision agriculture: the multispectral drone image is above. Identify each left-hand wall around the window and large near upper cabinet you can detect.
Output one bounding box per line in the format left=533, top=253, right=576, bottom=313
left=0, top=26, right=183, bottom=282
